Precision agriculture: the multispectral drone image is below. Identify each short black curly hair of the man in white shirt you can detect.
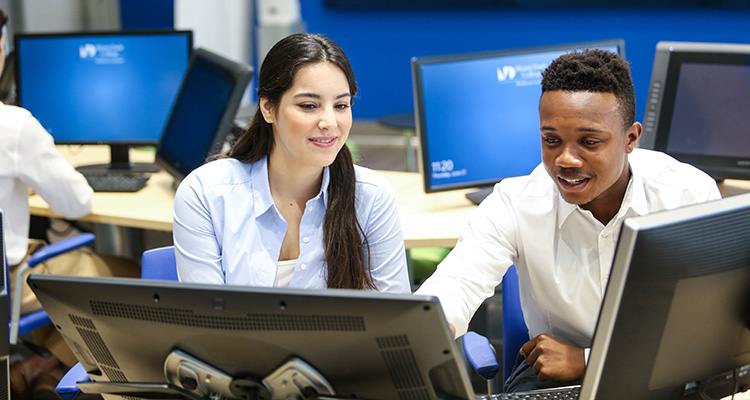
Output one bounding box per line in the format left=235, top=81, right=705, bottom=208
left=542, top=50, right=635, bottom=130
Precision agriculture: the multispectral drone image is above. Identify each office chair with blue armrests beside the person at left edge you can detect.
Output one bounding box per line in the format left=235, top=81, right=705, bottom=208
left=6, top=233, right=94, bottom=344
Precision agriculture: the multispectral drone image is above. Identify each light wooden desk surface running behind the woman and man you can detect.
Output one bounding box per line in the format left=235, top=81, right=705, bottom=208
left=29, top=145, right=750, bottom=248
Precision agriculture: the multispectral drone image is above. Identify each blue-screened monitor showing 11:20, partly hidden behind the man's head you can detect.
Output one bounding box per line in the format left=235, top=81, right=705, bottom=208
left=412, top=39, right=625, bottom=202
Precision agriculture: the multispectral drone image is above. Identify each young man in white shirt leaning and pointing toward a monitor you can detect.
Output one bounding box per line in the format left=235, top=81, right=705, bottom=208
left=417, top=50, right=721, bottom=392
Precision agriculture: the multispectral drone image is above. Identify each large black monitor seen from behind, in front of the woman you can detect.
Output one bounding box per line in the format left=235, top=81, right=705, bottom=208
left=29, top=275, right=474, bottom=400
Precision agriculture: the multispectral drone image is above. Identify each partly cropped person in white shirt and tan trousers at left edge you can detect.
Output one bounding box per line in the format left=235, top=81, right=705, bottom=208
left=0, top=9, right=139, bottom=399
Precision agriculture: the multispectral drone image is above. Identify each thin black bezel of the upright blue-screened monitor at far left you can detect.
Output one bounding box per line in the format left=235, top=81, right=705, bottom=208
left=13, top=29, right=194, bottom=148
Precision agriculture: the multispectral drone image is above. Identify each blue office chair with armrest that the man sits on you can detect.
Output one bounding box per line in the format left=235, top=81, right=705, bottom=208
left=463, top=266, right=529, bottom=394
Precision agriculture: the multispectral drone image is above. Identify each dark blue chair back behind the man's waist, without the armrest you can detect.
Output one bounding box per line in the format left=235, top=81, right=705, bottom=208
left=502, top=265, right=529, bottom=382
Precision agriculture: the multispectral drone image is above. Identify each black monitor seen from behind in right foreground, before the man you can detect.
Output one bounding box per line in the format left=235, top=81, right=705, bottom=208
left=580, top=194, right=750, bottom=400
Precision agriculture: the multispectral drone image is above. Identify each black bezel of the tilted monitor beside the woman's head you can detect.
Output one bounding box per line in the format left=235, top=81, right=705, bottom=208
left=155, top=48, right=254, bottom=184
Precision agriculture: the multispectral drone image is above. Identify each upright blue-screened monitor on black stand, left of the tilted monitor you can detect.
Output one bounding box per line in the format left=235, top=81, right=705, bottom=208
left=15, top=30, right=192, bottom=173
